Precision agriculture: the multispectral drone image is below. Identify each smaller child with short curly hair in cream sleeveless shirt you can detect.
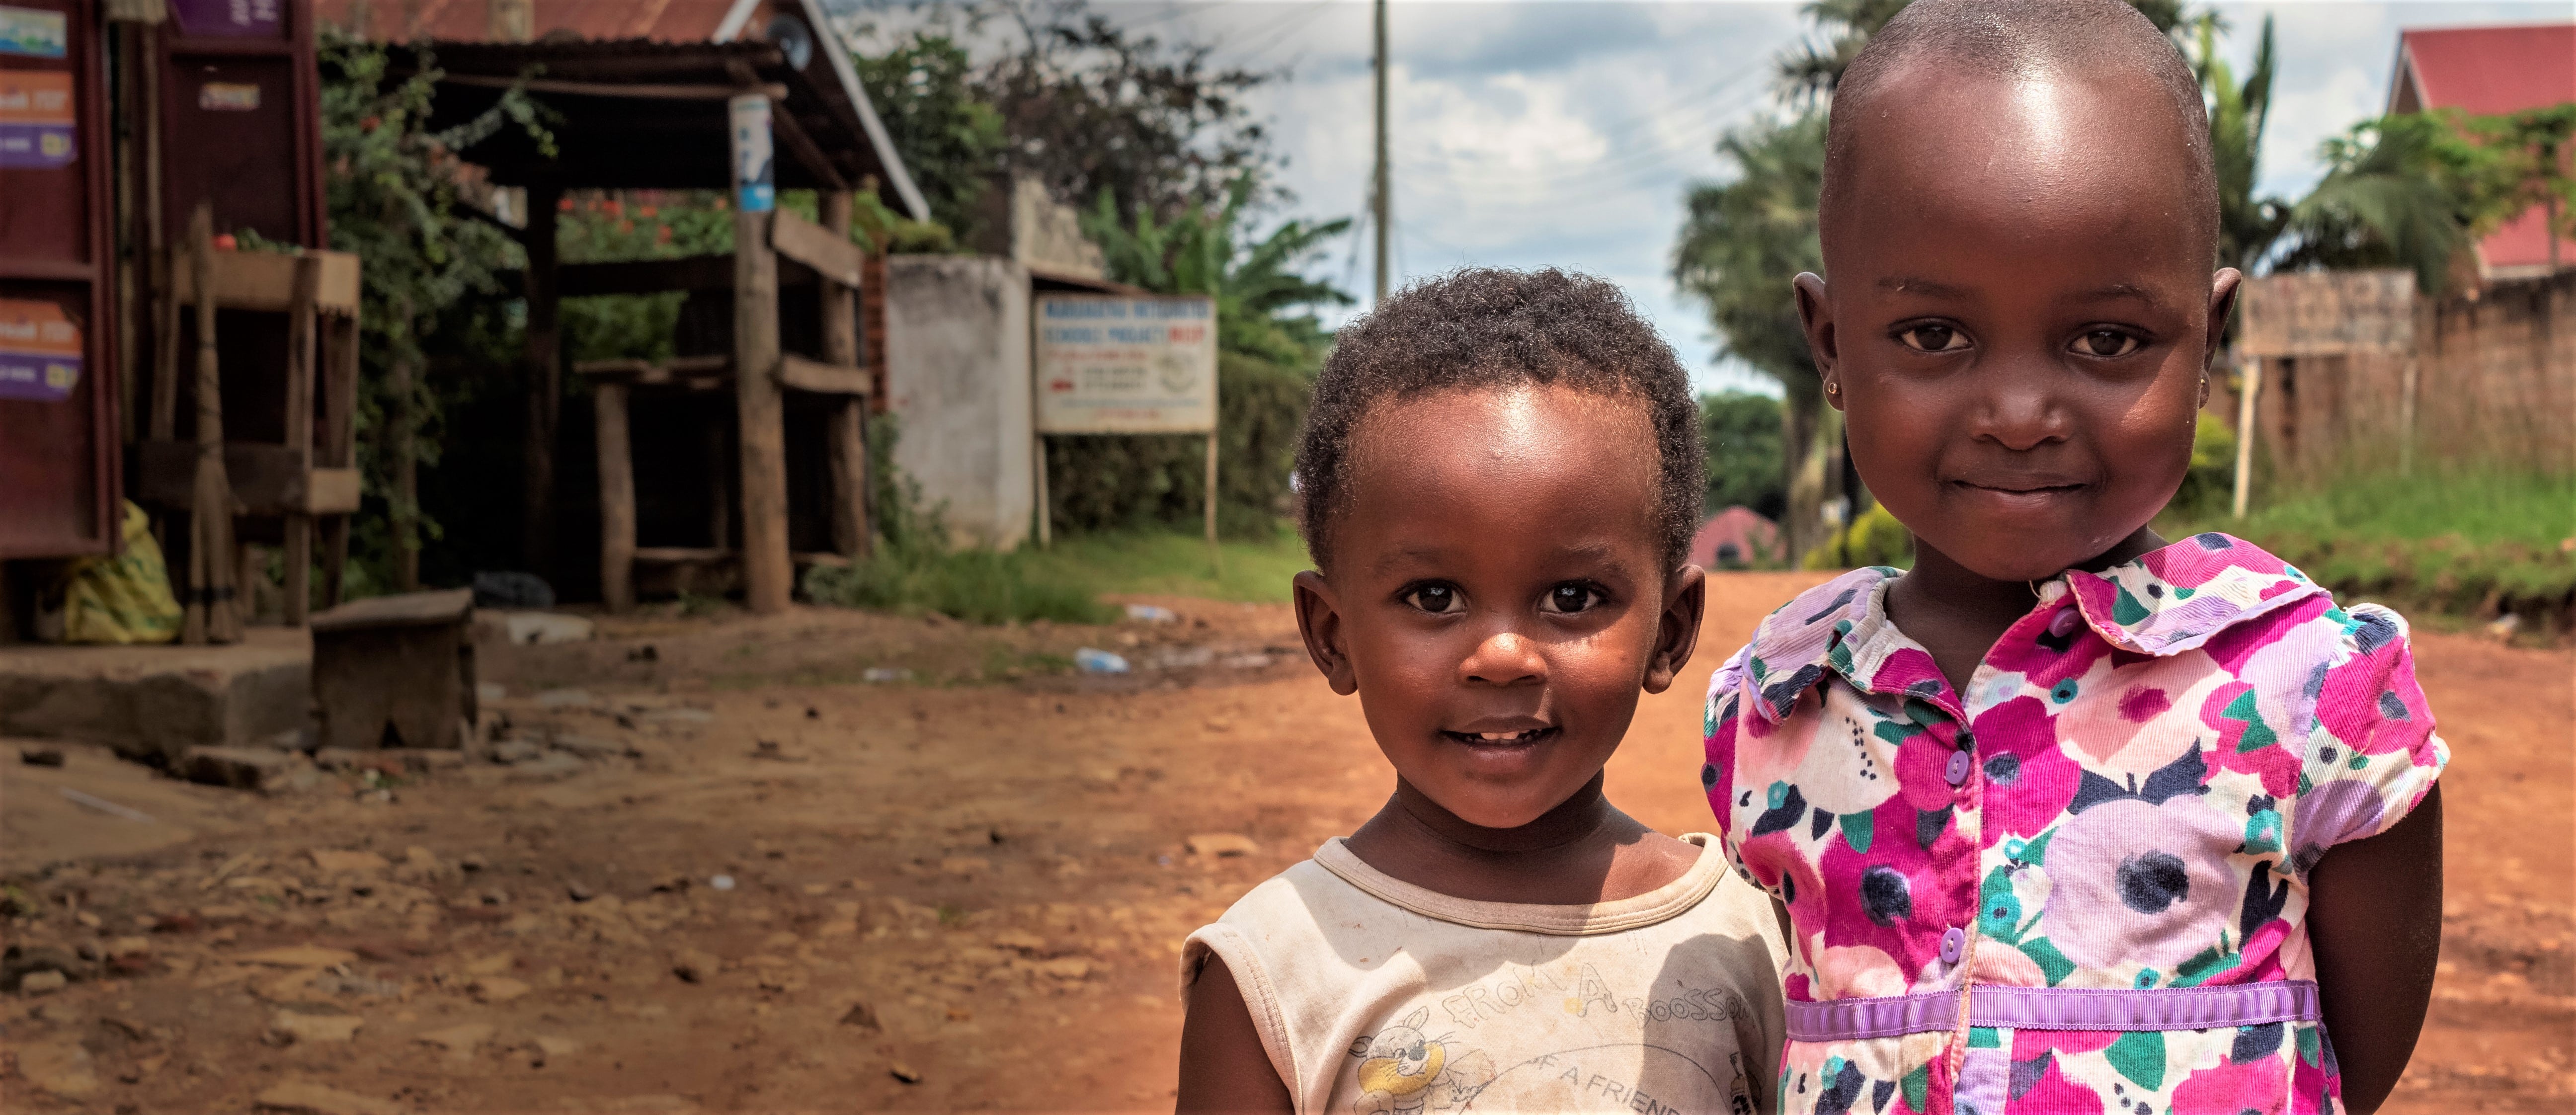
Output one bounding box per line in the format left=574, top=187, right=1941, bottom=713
left=1180, top=270, right=1780, bottom=1115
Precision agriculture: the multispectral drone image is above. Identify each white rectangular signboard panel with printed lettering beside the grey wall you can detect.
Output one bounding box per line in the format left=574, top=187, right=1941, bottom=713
left=1036, top=294, right=1216, bottom=433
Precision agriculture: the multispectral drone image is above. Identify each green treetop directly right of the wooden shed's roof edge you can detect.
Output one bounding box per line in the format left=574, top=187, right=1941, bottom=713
left=850, top=28, right=1010, bottom=239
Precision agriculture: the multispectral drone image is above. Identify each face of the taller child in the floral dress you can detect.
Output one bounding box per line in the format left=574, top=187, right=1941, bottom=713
left=1798, top=62, right=2236, bottom=579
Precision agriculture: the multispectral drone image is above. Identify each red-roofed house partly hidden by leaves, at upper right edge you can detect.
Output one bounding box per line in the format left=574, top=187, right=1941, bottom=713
left=2388, top=23, right=2576, bottom=281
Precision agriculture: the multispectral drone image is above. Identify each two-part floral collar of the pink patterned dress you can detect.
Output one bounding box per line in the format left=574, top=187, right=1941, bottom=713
left=1747, top=531, right=2326, bottom=723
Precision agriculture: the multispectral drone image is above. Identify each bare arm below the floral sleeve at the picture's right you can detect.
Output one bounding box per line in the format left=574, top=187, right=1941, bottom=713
left=2308, top=783, right=2442, bottom=1115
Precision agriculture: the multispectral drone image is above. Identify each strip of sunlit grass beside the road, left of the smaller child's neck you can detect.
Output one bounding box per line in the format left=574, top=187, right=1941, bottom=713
left=1025, top=525, right=1314, bottom=603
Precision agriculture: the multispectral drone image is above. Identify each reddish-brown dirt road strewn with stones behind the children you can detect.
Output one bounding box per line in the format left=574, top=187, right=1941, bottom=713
left=0, top=574, right=2576, bottom=1113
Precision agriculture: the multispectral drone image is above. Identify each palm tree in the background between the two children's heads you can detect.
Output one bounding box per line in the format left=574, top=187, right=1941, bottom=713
left=1672, top=111, right=1842, bottom=556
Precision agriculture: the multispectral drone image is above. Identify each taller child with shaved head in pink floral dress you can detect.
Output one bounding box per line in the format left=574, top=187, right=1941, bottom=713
left=1700, top=0, right=2447, bottom=1115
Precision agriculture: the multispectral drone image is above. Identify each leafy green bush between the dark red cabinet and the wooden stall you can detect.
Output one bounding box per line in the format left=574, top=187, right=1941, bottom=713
left=317, top=26, right=554, bottom=584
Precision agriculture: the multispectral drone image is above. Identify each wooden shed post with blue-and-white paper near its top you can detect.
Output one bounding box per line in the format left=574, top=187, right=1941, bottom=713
left=729, top=90, right=796, bottom=616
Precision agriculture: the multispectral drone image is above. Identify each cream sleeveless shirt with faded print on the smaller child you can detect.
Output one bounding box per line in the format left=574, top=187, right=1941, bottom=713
left=1180, top=834, right=1785, bottom=1115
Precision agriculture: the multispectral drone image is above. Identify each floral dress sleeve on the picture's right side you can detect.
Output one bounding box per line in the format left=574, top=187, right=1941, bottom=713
left=2290, top=605, right=2450, bottom=873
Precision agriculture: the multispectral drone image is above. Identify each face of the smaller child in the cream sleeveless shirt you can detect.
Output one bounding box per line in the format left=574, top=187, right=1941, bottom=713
left=1296, top=386, right=1700, bottom=829
